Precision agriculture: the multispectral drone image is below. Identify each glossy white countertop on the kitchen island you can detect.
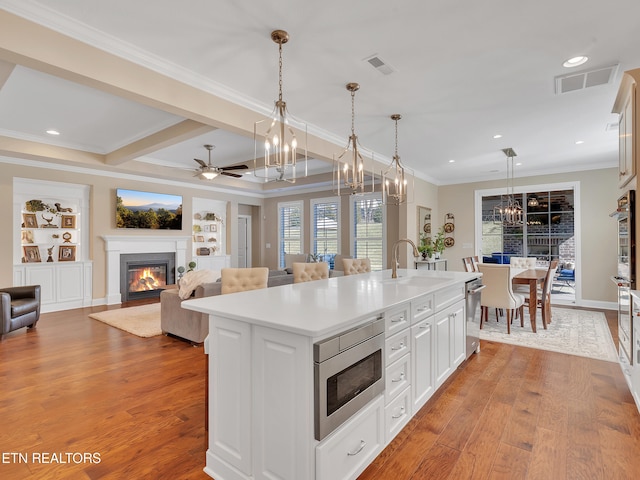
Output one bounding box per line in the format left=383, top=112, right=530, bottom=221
left=182, top=269, right=480, bottom=339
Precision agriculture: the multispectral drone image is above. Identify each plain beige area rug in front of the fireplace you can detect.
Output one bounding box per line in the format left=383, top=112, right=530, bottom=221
left=89, top=303, right=162, bottom=337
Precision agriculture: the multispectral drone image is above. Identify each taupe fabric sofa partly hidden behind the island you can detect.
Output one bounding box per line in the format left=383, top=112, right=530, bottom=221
left=160, top=270, right=293, bottom=345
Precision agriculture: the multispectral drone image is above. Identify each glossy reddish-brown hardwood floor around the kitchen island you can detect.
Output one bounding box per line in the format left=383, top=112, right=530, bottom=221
left=0, top=307, right=640, bottom=480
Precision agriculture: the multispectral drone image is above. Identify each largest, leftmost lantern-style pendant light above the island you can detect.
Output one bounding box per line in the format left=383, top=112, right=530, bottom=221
left=253, top=30, right=307, bottom=183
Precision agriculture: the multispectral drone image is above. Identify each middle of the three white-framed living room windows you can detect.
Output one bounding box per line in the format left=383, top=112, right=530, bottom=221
left=311, top=197, right=340, bottom=269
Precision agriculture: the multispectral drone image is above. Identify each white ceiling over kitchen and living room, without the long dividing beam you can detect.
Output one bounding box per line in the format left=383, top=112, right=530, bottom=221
left=0, top=0, right=640, bottom=194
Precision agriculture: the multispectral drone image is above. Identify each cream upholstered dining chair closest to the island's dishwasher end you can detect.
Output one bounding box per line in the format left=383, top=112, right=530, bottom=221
left=478, top=263, right=524, bottom=334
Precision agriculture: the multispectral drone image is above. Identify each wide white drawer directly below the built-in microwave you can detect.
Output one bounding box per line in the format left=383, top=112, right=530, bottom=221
left=316, top=395, right=384, bottom=480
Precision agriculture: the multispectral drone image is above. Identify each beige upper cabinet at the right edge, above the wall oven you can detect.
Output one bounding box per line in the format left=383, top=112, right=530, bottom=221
left=613, top=69, right=640, bottom=188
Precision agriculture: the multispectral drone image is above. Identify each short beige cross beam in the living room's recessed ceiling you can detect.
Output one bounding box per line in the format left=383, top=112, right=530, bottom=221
left=105, top=120, right=216, bottom=165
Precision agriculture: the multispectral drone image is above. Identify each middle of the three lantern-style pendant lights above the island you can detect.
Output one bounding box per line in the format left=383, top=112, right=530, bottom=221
left=333, top=83, right=375, bottom=195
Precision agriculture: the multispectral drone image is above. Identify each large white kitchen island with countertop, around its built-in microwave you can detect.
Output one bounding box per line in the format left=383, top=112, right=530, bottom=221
left=183, top=270, right=478, bottom=480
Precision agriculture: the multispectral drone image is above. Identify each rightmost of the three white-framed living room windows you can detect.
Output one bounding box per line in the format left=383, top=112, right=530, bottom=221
left=350, top=194, right=385, bottom=270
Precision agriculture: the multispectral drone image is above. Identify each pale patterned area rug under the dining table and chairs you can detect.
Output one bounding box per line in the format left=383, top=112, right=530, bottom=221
left=480, top=307, right=618, bottom=362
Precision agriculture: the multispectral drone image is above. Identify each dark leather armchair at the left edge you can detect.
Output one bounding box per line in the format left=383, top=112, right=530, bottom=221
left=0, top=285, right=40, bottom=338
